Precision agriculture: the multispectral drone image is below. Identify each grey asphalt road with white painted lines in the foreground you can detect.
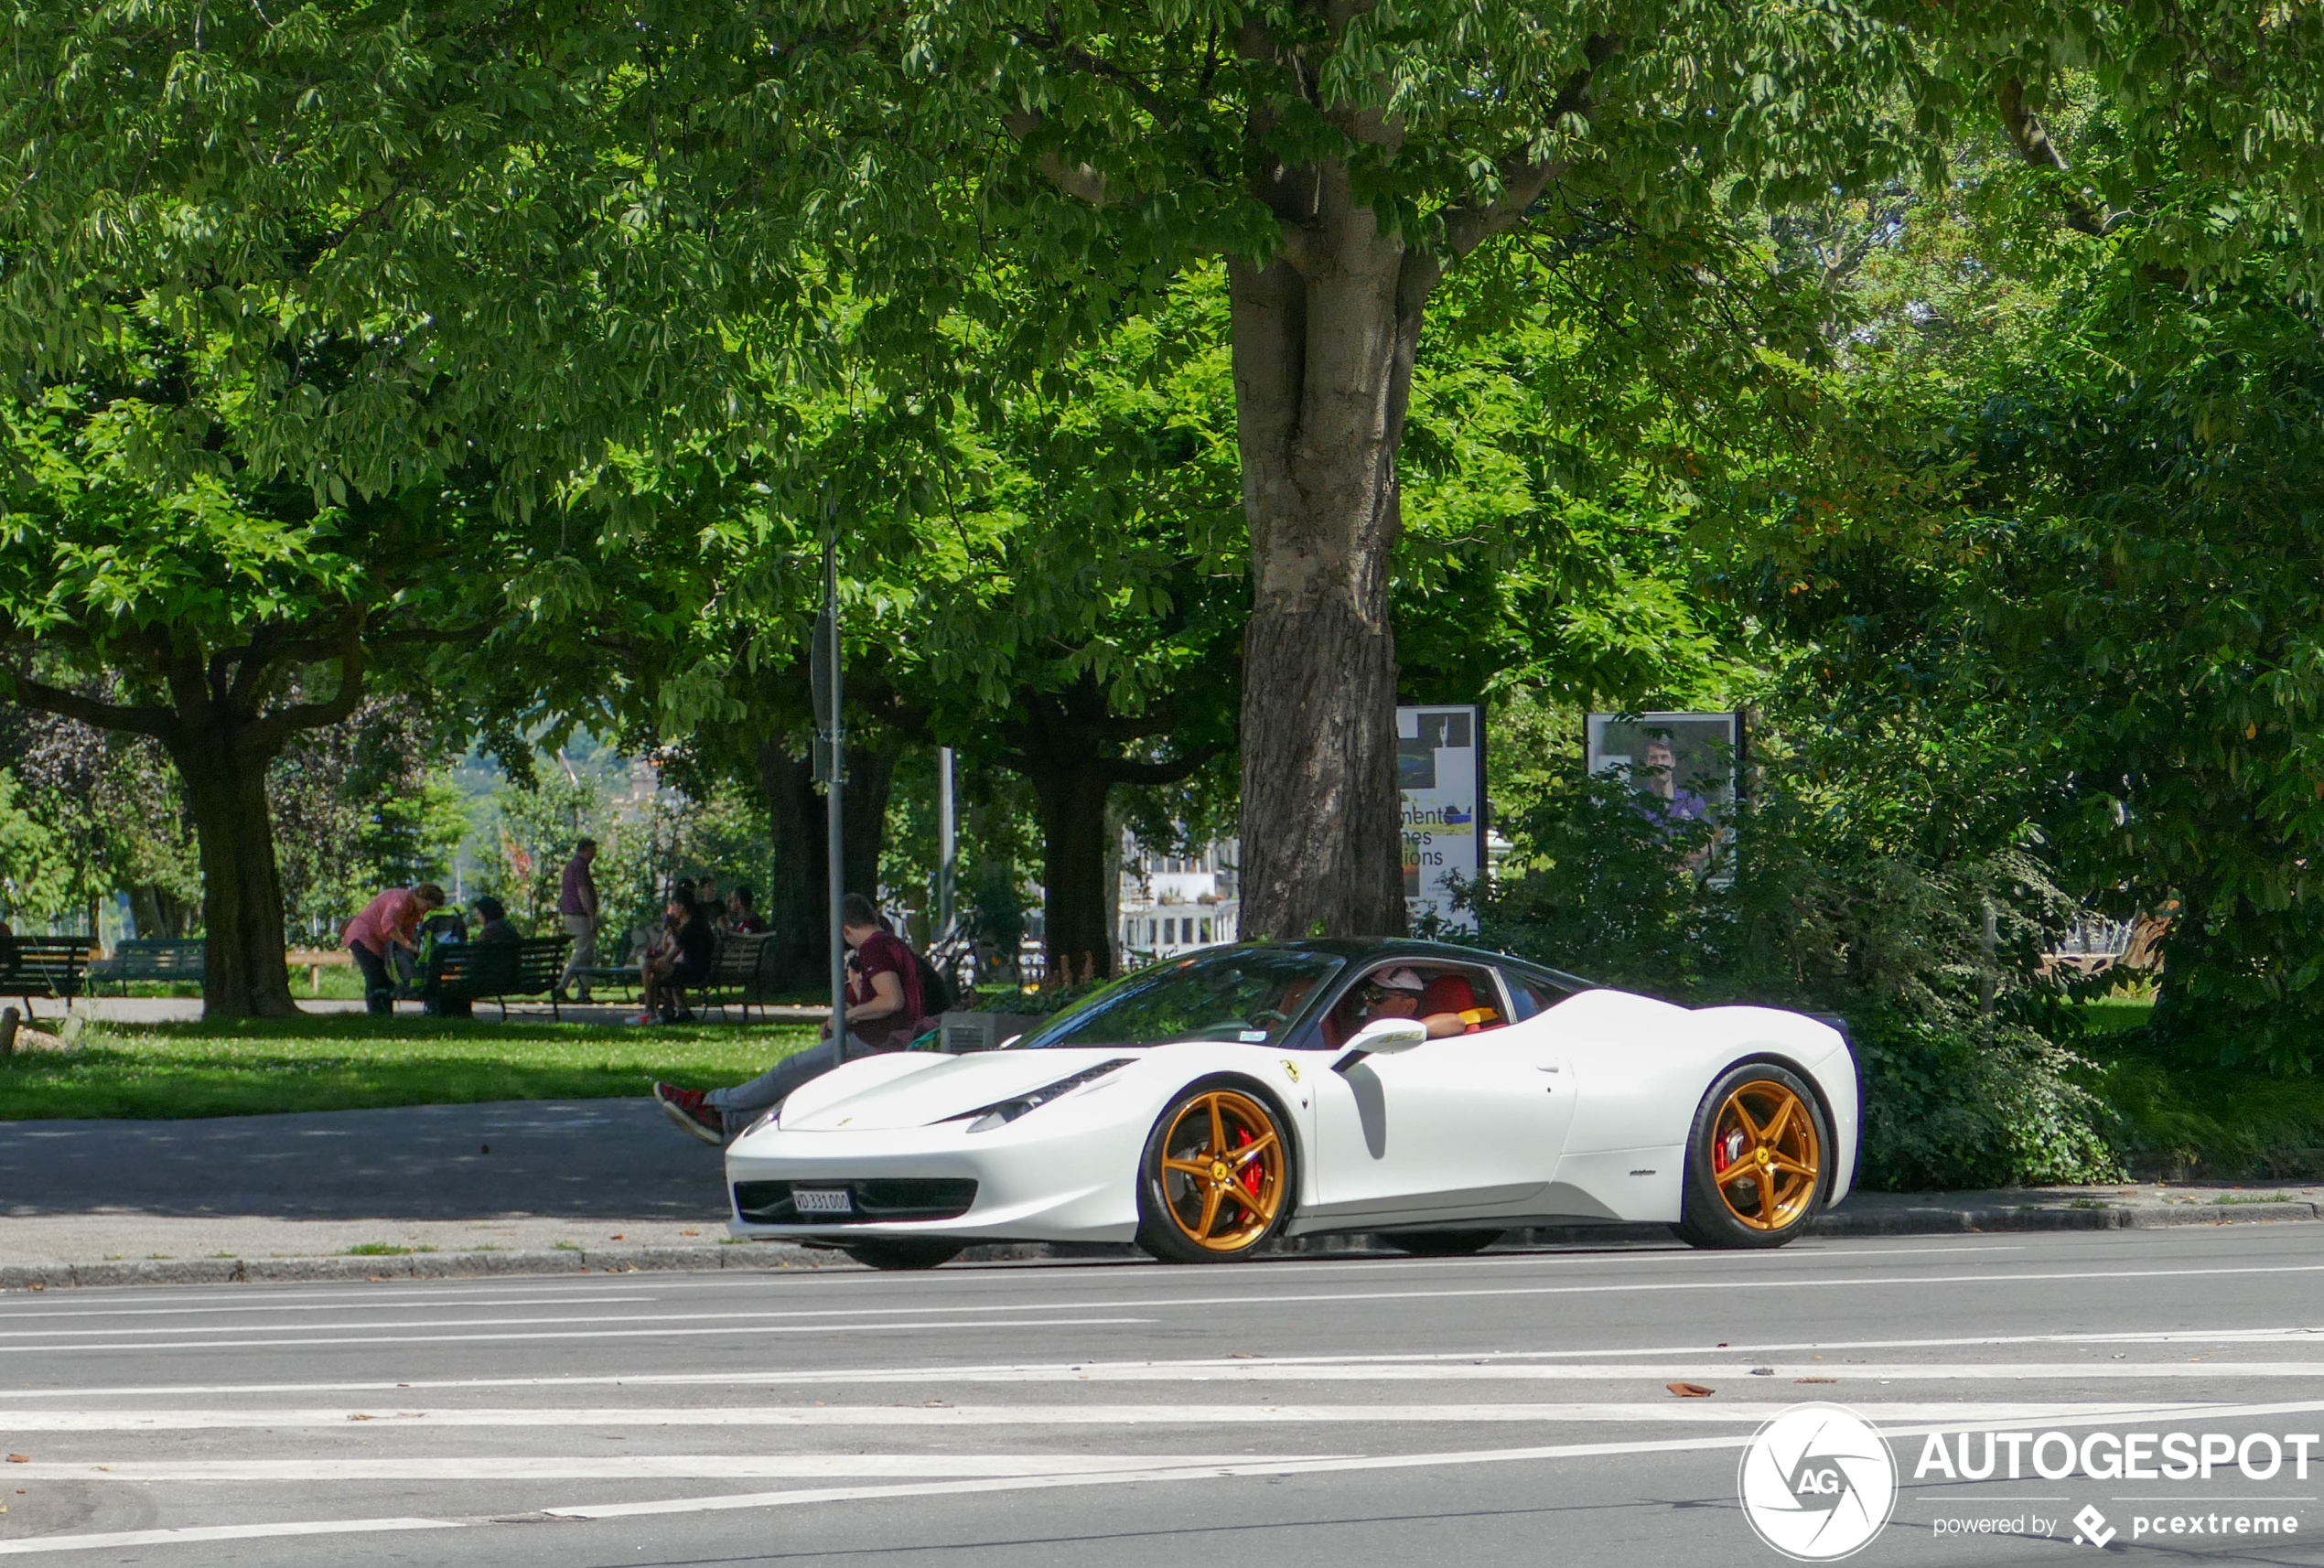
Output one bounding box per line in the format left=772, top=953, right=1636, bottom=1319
left=0, top=1224, right=2324, bottom=1568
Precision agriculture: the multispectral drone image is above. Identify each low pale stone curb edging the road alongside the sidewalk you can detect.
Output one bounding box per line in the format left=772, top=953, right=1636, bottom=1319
left=0, top=1201, right=2324, bottom=1292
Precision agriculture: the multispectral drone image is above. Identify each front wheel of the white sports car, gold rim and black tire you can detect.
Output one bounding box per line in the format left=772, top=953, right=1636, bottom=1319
left=1139, top=1078, right=1292, bottom=1263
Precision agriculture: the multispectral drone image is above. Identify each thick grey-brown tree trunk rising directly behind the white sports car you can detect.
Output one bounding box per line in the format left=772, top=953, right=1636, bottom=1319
left=1227, top=219, right=1434, bottom=939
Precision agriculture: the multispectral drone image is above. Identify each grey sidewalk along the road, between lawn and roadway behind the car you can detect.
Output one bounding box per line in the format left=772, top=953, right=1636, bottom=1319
left=0, top=1099, right=2324, bottom=1289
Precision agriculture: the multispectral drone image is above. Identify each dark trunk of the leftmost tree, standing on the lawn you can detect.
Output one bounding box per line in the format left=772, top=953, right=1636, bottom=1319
left=169, top=738, right=297, bottom=1022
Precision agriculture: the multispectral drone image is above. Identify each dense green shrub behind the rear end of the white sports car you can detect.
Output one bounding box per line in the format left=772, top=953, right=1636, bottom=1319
left=1473, top=768, right=2122, bottom=1189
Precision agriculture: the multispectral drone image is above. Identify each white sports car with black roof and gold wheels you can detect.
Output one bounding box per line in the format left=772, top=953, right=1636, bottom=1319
left=727, top=940, right=1859, bottom=1268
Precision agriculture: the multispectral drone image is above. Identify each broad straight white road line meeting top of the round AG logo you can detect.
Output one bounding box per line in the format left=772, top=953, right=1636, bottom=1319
left=7, top=1380, right=2277, bottom=1431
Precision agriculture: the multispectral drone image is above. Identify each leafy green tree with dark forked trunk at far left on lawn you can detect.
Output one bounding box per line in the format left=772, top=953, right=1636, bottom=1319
left=0, top=403, right=530, bottom=1017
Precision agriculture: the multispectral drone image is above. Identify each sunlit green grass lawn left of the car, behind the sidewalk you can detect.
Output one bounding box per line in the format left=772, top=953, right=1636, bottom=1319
left=0, top=1017, right=816, bottom=1122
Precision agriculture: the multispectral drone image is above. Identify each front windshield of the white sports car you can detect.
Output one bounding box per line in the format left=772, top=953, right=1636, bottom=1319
left=1018, top=948, right=1346, bottom=1050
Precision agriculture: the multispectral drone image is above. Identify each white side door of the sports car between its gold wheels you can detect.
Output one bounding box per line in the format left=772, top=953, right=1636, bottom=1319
left=1304, top=964, right=1574, bottom=1222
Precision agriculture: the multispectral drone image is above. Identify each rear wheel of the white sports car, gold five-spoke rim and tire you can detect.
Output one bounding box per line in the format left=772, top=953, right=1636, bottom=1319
left=1678, top=1061, right=1836, bottom=1248
